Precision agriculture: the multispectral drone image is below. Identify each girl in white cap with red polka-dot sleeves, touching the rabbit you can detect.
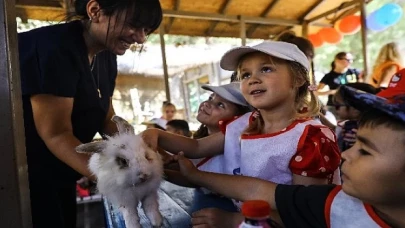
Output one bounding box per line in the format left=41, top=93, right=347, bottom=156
left=143, top=41, right=340, bottom=225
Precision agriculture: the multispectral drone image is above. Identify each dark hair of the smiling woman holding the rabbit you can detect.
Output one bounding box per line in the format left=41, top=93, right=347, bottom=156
left=67, top=0, right=163, bottom=35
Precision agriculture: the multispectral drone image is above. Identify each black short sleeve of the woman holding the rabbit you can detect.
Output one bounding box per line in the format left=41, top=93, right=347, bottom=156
left=20, top=37, right=80, bottom=97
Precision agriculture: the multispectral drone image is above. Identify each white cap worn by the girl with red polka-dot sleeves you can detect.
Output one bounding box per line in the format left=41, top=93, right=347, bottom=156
left=220, top=41, right=311, bottom=71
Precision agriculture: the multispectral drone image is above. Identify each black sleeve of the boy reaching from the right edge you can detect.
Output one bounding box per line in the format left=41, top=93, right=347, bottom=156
left=275, top=185, right=335, bottom=228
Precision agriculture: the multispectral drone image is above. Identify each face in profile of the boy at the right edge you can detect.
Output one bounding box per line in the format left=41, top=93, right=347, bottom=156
left=342, top=126, right=405, bottom=207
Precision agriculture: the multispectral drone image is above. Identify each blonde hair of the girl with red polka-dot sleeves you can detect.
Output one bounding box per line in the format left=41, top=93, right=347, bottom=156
left=237, top=53, right=320, bottom=134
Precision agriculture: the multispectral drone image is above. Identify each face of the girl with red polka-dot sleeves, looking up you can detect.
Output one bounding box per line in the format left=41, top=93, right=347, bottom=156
left=240, top=53, right=295, bottom=110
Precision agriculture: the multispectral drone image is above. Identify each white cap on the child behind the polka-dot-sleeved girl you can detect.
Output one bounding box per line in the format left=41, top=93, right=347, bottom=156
left=201, top=82, right=248, bottom=106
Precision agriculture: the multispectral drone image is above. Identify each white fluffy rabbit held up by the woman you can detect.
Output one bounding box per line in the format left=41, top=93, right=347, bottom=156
left=76, top=116, right=163, bottom=228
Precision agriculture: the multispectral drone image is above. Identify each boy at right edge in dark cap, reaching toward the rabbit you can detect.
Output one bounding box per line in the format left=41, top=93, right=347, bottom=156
left=172, top=69, right=405, bottom=228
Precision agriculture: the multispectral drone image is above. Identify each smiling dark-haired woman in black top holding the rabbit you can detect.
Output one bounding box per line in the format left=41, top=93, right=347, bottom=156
left=18, top=0, right=162, bottom=228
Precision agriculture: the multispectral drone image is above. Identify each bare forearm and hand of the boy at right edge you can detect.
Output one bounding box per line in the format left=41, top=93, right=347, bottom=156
left=175, top=153, right=277, bottom=210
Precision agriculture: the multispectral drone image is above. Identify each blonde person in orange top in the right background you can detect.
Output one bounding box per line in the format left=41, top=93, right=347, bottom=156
left=369, top=42, right=403, bottom=88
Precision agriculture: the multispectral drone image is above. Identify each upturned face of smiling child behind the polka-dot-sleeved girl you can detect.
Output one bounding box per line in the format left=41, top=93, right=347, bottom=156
left=197, top=93, right=238, bottom=127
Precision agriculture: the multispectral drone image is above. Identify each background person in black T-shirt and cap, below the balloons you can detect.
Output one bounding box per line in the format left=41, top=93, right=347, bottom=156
left=317, top=52, right=362, bottom=111
